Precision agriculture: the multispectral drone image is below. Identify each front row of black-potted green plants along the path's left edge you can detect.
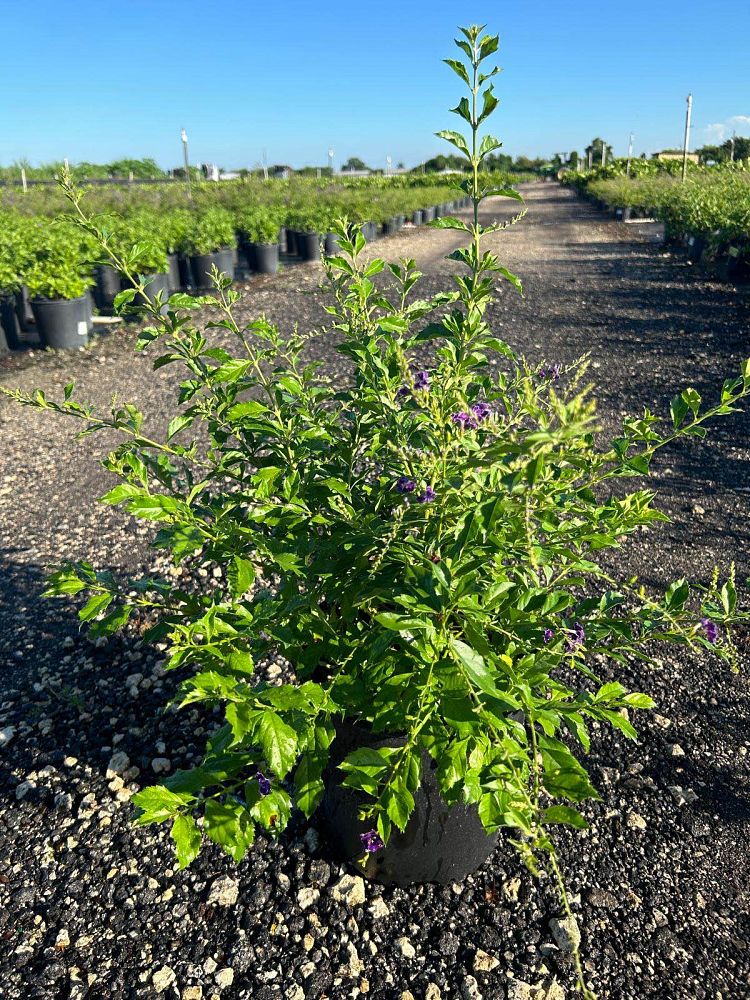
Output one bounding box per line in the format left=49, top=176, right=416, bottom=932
left=0, top=185, right=482, bottom=348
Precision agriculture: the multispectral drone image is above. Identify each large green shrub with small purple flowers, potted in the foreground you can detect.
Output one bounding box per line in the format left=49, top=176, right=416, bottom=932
left=6, top=33, right=750, bottom=997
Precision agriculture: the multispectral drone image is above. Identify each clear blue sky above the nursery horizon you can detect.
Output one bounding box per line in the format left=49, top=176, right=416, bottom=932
left=0, top=0, right=750, bottom=168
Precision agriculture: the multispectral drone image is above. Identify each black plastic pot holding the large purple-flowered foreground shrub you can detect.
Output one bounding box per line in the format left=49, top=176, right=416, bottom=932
left=319, top=723, right=498, bottom=886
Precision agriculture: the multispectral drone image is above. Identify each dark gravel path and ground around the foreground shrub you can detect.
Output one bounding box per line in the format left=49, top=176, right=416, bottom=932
left=0, top=184, right=750, bottom=1000
